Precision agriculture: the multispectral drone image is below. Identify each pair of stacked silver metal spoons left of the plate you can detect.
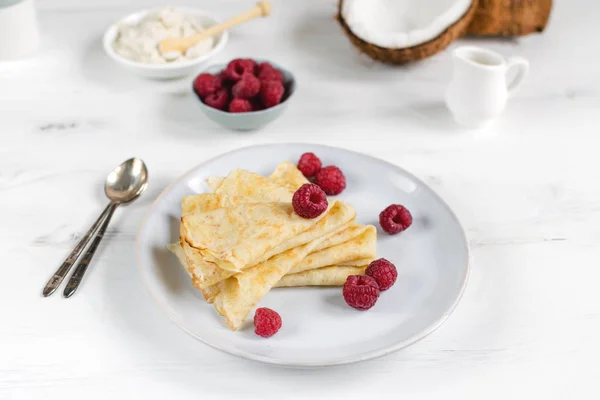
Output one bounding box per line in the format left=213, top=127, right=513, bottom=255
left=43, top=158, right=148, bottom=297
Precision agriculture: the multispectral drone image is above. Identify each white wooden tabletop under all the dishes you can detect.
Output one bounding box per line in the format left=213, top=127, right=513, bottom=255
left=0, top=0, right=600, bottom=400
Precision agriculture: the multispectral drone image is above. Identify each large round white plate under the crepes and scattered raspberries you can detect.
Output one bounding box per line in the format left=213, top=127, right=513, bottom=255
left=137, top=144, right=469, bottom=366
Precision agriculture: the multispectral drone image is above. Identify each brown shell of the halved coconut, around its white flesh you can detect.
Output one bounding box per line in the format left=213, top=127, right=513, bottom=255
left=337, top=0, right=481, bottom=64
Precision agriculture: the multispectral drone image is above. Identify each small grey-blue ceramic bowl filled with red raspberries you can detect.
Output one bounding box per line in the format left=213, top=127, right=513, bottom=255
left=192, top=58, right=296, bottom=131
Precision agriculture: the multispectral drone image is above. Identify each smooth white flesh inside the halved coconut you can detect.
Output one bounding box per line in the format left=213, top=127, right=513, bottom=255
left=342, top=0, right=471, bottom=49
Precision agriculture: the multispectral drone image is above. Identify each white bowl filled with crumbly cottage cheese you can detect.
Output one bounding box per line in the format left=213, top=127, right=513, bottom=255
left=103, top=7, right=228, bottom=79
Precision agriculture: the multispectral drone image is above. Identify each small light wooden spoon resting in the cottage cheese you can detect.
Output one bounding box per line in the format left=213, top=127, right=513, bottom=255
left=159, top=0, right=271, bottom=53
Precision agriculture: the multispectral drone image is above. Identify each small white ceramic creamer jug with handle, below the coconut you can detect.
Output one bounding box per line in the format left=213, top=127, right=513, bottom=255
left=446, top=46, right=529, bottom=128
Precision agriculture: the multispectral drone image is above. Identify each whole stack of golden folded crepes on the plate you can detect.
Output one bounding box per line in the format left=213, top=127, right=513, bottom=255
left=168, top=162, right=376, bottom=330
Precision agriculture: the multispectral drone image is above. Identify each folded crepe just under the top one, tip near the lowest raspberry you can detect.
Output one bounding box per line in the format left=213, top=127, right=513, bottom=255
left=214, top=202, right=356, bottom=330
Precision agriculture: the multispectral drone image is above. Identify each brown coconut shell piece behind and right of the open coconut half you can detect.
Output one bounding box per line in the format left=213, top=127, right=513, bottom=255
left=467, top=0, right=552, bottom=36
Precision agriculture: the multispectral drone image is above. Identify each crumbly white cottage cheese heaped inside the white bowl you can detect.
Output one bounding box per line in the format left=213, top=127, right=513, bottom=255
left=113, top=8, right=214, bottom=64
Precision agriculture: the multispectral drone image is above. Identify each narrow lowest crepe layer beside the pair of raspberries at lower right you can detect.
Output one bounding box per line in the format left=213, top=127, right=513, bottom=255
left=275, top=264, right=368, bottom=287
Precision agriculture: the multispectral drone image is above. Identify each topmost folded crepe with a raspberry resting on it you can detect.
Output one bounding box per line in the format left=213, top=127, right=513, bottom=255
left=181, top=201, right=337, bottom=272
